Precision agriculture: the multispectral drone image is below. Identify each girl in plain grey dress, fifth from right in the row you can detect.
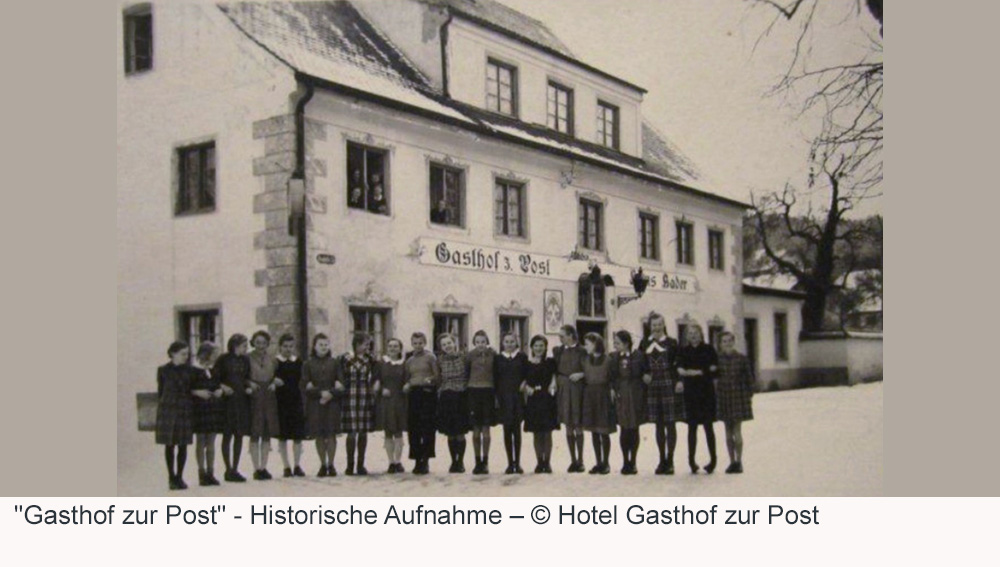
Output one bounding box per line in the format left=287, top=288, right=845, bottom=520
left=581, top=333, right=615, bottom=474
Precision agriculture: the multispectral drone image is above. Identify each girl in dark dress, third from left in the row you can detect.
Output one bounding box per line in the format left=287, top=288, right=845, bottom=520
left=215, top=333, right=250, bottom=482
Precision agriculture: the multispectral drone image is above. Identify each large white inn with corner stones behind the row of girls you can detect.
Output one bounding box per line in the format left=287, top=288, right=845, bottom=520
left=118, top=0, right=745, bottom=460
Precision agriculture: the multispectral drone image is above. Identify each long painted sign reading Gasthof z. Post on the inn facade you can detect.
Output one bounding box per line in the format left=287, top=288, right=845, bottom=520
left=418, top=238, right=698, bottom=293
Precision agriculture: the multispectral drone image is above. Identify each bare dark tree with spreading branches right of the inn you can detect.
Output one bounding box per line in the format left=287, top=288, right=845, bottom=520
left=751, top=0, right=883, bottom=331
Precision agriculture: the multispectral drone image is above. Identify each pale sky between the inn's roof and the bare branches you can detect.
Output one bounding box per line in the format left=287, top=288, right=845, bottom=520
left=499, top=0, right=884, bottom=214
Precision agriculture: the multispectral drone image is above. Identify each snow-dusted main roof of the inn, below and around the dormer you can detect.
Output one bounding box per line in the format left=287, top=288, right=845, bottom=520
left=219, top=0, right=746, bottom=207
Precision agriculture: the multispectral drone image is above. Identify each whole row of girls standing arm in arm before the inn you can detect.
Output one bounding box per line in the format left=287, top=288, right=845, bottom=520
left=156, top=313, right=754, bottom=490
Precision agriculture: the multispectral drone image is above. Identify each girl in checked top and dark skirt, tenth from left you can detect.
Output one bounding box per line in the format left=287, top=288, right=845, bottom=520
left=437, top=333, right=469, bottom=473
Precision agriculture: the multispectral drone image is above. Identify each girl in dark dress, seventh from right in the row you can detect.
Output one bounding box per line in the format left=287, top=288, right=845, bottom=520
left=524, top=335, right=559, bottom=474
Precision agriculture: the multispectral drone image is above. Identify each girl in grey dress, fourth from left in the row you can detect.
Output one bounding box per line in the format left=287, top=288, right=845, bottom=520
left=250, top=331, right=281, bottom=480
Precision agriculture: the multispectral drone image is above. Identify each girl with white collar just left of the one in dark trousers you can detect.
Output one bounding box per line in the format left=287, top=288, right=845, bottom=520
left=375, top=339, right=408, bottom=474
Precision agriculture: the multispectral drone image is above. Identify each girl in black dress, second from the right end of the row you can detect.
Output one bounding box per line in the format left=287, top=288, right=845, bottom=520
left=677, top=325, right=719, bottom=474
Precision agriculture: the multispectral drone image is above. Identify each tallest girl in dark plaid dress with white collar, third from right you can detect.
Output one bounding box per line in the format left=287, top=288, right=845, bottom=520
left=639, top=313, right=684, bottom=474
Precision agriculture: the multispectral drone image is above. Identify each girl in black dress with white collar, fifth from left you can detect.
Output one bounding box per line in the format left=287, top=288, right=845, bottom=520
left=274, top=333, right=306, bottom=478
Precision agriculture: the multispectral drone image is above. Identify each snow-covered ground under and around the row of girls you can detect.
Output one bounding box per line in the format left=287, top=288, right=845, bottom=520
left=118, top=382, right=882, bottom=497
